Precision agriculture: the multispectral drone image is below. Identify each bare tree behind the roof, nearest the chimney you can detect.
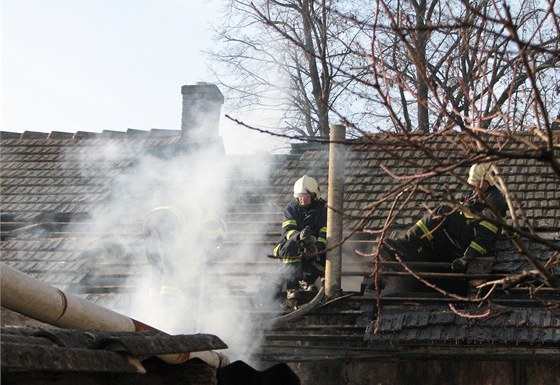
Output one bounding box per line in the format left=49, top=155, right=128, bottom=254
left=208, top=0, right=362, bottom=137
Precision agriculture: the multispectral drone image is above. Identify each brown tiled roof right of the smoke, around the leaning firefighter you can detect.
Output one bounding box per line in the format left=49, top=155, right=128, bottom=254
left=264, top=133, right=560, bottom=357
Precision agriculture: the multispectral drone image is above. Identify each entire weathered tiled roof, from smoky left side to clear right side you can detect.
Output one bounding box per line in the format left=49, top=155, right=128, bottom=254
left=0, top=127, right=560, bottom=364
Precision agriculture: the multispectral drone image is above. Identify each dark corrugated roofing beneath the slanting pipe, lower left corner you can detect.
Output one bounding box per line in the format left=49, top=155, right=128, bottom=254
left=2, top=327, right=227, bottom=379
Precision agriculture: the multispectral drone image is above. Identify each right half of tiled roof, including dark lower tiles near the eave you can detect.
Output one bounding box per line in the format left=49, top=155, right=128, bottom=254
left=264, top=129, right=560, bottom=360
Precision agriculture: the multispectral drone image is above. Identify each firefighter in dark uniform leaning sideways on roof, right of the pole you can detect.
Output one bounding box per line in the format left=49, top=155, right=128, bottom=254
left=381, top=163, right=507, bottom=290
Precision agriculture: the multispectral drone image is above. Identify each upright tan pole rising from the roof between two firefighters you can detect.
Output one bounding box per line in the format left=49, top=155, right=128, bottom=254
left=325, top=124, right=346, bottom=298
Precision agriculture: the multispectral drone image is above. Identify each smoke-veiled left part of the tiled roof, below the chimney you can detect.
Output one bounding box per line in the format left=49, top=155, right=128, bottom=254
left=0, top=130, right=283, bottom=306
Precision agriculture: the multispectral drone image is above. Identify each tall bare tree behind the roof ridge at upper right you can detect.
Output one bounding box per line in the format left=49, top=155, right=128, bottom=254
left=358, top=0, right=560, bottom=132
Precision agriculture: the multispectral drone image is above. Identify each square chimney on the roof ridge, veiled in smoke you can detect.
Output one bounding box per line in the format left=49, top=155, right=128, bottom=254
left=181, top=83, right=224, bottom=144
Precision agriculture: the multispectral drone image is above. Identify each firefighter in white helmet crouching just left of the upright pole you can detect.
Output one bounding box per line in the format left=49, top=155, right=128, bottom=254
left=274, top=175, right=327, bottom=310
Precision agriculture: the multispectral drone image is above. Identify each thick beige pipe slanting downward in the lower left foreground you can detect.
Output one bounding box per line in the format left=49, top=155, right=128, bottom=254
left=0, top=263, right=229, bottom=368
